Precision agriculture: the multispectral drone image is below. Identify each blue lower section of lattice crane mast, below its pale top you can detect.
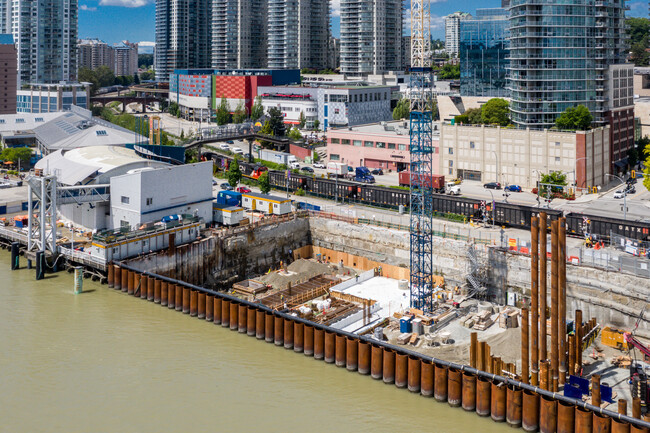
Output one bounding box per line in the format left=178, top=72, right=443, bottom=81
left=409, top=67, right=434, bottom=311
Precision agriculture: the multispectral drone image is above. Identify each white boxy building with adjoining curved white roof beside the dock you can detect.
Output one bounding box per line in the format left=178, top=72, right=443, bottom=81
left=35, top=146, right=212, bottom=230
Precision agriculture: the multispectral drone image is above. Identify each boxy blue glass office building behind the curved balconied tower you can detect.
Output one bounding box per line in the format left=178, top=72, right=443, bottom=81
left=458, top=8, right=509, bottom=97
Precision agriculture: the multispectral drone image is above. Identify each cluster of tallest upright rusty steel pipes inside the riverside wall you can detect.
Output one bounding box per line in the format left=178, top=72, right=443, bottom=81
left=521, top=212, right=567, bottom=391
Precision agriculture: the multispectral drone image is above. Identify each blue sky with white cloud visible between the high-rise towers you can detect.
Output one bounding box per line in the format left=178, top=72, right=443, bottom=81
left=79, top=0, right=648, bottom=43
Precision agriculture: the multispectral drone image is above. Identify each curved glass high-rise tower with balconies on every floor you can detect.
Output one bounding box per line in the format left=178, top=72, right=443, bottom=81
left=509, top=0, right=627, bottom=128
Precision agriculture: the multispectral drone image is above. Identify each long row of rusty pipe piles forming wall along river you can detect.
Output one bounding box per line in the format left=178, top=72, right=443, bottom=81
left=108, top=258, right=650, bottom=433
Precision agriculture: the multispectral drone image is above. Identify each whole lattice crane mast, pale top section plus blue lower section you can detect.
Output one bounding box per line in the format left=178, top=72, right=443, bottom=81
left=409, top=0, right=434, bottom=312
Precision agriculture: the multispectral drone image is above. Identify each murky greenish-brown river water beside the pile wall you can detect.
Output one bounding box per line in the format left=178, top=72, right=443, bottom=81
left=0, top=251, right=509, bottom=433
